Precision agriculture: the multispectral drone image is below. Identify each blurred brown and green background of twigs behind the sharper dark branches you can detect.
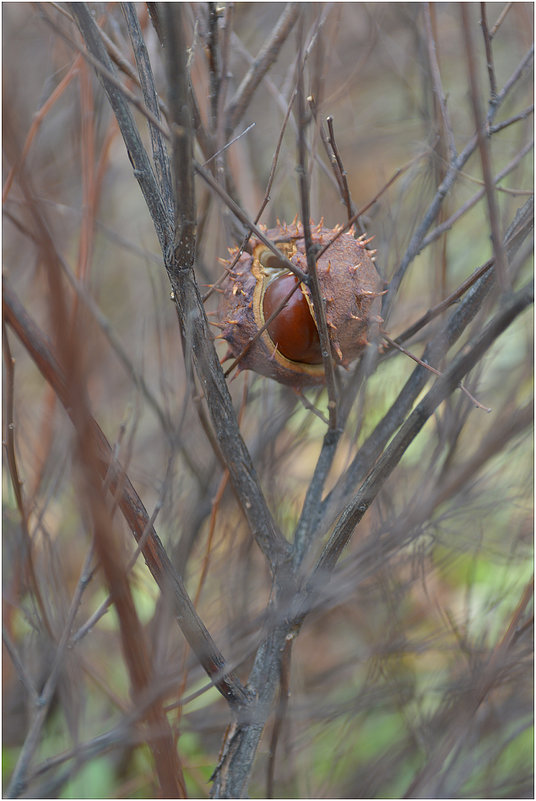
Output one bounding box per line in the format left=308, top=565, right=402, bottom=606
left=2, top=3, right=533, bottom=798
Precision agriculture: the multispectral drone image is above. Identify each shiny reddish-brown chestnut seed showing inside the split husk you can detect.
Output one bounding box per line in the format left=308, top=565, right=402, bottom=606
left=263, top=273, right=322, bottom=364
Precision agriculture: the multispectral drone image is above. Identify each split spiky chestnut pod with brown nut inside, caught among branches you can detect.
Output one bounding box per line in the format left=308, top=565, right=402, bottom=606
left=220, top=221, right=381, bottom=387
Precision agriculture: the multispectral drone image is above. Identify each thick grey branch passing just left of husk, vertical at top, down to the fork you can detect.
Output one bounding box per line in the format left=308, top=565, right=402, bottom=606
left=164, top=4, right=290, bottom=570
